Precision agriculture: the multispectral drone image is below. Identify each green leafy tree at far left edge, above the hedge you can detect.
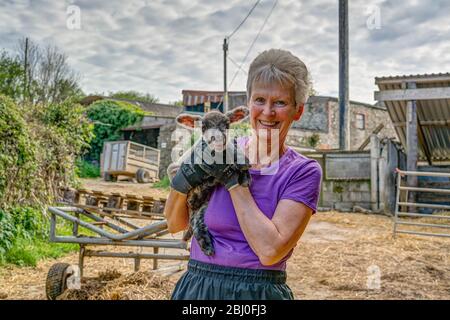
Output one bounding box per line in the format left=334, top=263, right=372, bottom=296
left=0, top=51, right=23, bottom=101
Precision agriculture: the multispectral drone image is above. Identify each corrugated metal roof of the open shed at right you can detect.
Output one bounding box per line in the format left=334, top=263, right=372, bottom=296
left=375, top=73, right=450, bottom=161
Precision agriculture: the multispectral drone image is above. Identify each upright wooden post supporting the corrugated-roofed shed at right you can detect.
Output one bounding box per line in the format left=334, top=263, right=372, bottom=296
left=406, top=82, right=418, bottom=212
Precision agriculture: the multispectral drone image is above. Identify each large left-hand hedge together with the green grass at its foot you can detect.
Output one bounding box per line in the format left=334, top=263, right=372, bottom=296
left=0, top=95, right=93, bottom=265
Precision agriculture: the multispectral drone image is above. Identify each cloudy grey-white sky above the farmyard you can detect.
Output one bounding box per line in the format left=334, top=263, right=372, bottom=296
left=0, top=0, right=450, bottom=103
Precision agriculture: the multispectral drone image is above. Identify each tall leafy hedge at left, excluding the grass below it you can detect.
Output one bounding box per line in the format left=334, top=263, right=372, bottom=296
left=0, top=95, right=93, bottom=208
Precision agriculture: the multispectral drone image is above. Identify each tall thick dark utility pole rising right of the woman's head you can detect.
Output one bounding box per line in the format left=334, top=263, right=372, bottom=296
left=339, top=0, right=350, bottom=150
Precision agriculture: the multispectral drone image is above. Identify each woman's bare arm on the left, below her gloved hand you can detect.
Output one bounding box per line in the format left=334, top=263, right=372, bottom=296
left=164, top=189, right=189, bottom=233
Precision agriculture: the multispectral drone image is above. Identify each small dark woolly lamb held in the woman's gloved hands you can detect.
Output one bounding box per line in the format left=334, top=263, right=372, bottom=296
left=167, top=107, right=250, bottom=256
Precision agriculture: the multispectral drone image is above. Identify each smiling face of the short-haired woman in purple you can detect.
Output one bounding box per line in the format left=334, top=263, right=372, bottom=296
left=248, top=83, right=303, bottom=146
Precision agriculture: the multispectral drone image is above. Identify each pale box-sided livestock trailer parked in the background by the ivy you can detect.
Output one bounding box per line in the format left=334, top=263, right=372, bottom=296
left=100, top=141, right=160, bottom=183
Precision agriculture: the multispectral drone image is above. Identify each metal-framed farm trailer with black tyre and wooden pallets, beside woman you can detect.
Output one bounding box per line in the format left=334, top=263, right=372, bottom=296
left=46, top=188, right=189, bottom=300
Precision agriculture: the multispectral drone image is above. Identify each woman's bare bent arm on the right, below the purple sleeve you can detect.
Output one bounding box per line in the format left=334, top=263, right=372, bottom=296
left=230, top=186, right=312, bottom=266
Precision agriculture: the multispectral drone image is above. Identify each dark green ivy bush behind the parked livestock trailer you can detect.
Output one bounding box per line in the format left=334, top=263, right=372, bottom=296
left=87, top=100, right=146, bottom=160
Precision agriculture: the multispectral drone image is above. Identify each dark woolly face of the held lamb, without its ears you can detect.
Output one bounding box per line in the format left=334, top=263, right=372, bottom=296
left=202, top=111, right=230, bottom=152
